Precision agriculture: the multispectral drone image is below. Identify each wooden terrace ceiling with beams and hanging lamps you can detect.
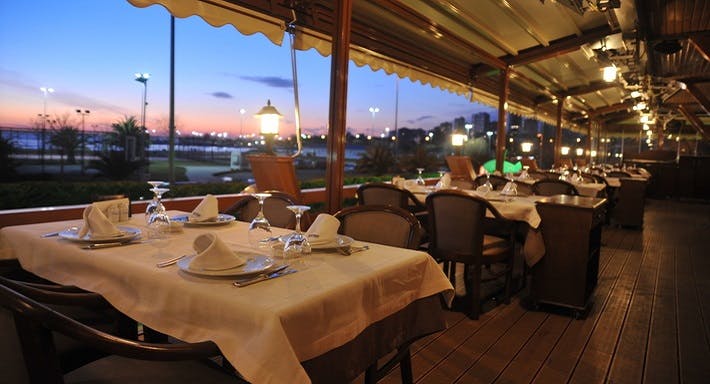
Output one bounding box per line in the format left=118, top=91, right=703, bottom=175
left=147, top=0, right=710, bottom=139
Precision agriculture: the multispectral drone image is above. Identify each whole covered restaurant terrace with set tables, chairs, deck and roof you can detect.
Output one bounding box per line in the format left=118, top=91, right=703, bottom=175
left=0, top=0, right=710, bottom=384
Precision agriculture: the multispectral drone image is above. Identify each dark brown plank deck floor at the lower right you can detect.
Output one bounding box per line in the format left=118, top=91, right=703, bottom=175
left=381, top=200, right=710, bottom=384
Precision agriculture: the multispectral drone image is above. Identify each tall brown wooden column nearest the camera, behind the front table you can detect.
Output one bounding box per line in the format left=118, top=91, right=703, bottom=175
left=325, top=0, right=352, bottom=213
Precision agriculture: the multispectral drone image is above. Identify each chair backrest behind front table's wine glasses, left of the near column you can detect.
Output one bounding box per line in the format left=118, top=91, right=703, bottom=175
left=223, top=191, right=297, bottom=229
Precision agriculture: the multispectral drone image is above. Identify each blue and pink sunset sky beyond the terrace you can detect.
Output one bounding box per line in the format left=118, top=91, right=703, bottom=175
left=0, top=0, right=493, bottom=136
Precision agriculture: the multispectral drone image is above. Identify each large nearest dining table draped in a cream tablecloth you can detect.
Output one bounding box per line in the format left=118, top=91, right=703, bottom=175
left=0, top=211, right=454, bottom=384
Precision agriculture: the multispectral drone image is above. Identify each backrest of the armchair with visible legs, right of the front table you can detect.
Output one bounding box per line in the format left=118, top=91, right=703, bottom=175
left=426, top=190, right=500, bottom=264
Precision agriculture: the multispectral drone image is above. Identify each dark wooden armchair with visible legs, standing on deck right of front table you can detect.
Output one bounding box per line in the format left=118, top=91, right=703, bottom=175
left=426, top=190, right=516, bottom=319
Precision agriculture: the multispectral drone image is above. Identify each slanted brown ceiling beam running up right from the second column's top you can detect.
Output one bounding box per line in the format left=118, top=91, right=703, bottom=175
left=501, top=25, right=613, bottom=66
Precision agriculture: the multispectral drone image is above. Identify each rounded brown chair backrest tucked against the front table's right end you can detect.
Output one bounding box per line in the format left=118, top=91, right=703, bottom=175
left=335, top=205, right=423, bottom=249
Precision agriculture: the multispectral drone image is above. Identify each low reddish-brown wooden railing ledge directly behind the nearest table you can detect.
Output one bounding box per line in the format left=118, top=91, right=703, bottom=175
left=0, top=185, right=358, bottom=228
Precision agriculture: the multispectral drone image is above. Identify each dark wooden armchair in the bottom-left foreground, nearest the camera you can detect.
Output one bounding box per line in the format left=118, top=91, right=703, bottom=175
left=0, top=277, right=238, bottom=384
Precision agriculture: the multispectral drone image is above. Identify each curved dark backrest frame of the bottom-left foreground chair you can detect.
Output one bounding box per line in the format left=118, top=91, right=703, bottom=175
left=0, top=277, right=220, bottom=383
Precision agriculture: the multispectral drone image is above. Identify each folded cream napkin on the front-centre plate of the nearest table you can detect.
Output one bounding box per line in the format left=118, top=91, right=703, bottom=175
left=190, top=232, right=246, bottom=271
